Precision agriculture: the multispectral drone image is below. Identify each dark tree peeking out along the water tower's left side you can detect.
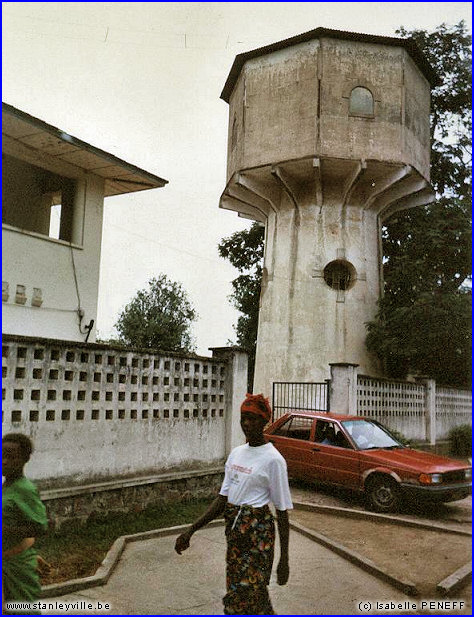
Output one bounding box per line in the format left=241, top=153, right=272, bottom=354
left=218, top=223, right=264, bottom=392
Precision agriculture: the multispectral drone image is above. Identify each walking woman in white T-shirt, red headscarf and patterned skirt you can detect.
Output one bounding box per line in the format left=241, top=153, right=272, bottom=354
left=175, top=394, right=293, bottom=615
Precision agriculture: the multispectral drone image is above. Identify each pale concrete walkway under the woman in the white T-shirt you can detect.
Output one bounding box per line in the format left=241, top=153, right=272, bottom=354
left=42, top=527, right=415, bottom=615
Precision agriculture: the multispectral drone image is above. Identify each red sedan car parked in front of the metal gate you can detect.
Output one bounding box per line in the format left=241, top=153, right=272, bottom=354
left=265, top=411, right=472, bottom=512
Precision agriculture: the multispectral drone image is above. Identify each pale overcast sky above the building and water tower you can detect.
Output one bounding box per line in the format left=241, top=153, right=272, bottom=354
left=2, top=2, right=471, bottom=355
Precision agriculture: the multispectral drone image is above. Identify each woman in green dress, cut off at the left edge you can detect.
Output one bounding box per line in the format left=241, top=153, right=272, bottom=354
left=2, top=433, right=48, bottom=615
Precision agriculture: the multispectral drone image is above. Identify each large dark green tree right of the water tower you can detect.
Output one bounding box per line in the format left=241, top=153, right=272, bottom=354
left=367, top=22, right=472, bottom=386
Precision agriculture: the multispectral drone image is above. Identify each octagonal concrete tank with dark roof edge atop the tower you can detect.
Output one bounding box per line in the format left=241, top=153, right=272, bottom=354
left=222, top=28, right=436, bottom=181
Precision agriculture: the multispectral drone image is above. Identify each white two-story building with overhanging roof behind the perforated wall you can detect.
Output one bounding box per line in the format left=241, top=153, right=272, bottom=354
left=2, top=103, right=167, bottom=342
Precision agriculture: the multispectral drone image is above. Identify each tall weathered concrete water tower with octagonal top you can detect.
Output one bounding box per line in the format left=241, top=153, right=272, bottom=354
left=220, top=28, right=436, bottom=394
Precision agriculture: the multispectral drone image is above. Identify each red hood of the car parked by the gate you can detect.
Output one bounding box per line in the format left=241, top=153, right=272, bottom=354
left=360, top=448, right=469, bottom=473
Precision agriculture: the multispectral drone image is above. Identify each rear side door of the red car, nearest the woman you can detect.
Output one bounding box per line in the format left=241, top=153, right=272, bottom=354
left=268, top=415, right=315, bottom=479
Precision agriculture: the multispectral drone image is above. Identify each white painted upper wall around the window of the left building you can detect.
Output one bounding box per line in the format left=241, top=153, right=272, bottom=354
left=2, top=174, right=104, bottom=341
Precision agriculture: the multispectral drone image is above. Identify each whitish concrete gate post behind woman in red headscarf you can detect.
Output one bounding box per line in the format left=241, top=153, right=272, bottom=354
left=209, top=347, right=248, bottom=456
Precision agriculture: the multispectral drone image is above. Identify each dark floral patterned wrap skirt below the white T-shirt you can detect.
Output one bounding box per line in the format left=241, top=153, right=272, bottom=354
left=223, top=504, right=275, bottom=615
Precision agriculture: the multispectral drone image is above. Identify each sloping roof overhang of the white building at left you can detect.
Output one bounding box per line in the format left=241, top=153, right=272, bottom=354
left=2, top=103, right=168, bottom=197
